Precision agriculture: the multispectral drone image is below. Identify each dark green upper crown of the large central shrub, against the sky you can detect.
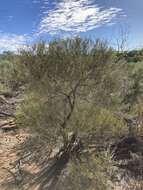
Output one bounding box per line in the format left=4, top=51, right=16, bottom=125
left=20, top=38, right=112, bottom=82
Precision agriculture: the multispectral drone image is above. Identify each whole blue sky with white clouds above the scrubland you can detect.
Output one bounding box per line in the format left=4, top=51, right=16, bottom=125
left=0, top=0, right=143, bottom=51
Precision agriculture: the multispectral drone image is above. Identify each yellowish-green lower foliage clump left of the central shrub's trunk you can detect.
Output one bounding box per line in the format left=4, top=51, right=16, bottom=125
left=16, top=92, right=58, bottom=141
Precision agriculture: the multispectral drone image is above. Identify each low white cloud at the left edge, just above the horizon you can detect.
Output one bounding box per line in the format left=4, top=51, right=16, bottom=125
left=0, top=33, right=29, bottom=52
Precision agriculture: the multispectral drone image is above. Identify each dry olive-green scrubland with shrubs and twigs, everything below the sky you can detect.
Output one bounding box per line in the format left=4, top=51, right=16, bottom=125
left=0, top=37, right=143, bottom=190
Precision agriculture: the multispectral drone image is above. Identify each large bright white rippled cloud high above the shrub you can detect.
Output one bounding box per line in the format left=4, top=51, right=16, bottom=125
left=38, top=0, right=122, bottom=35
